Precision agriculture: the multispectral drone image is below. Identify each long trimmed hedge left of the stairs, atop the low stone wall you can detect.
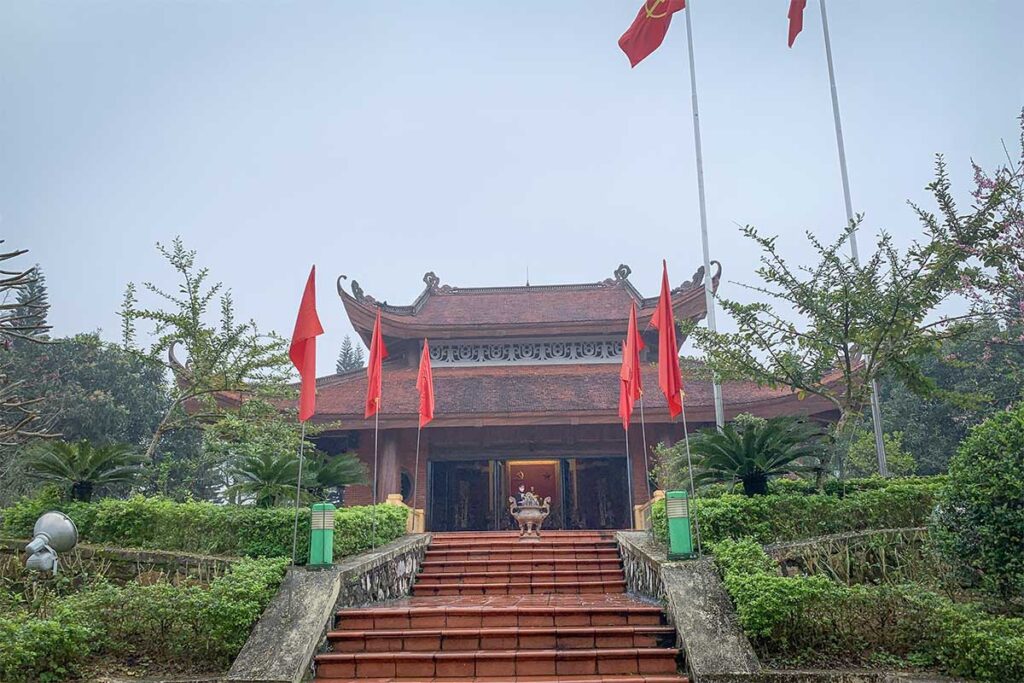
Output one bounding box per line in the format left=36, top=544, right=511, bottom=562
left=0, top=496, right=408, bottom=563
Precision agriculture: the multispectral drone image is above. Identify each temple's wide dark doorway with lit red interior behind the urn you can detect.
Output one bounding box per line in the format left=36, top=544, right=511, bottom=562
left=427, top=457, right=631, bottom=531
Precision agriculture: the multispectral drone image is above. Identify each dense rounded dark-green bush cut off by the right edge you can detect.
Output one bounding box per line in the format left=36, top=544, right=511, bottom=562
left=933, top=403, right=1024, bottom=609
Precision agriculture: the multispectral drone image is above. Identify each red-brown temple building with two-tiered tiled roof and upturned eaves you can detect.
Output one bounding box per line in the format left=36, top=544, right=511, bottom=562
left=313, top=265, right=831, bottom=530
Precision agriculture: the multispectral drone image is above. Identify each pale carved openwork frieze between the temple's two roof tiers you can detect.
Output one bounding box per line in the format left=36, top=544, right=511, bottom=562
left=430, top=339, right=623, bottom=366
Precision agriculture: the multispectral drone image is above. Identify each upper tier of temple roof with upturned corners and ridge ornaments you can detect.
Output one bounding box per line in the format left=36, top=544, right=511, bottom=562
left=337, top=261, right=722, bottom=340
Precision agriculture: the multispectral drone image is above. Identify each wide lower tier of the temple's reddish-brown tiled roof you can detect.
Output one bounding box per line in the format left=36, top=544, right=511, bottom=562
left=303, top=364, right=829, bottom=428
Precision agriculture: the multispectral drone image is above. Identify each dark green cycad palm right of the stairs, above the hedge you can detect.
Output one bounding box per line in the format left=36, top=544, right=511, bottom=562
left=691, top=417, right=824, bottom=496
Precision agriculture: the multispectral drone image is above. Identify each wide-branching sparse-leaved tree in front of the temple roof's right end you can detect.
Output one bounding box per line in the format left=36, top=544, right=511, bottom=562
left=692, top=139, right=1007, bottom=444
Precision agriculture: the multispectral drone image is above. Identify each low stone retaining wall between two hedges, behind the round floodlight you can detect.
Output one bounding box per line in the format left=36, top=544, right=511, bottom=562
left=0, top=539, right=238, bottom=584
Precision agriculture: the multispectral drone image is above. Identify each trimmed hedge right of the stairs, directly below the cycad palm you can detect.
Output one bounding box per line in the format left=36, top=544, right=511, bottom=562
left=651, top=477, right=942, bottom=544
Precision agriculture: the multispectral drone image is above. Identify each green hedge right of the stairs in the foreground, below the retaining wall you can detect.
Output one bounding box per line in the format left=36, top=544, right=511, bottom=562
left=713, top=540, right=1024, bottom=682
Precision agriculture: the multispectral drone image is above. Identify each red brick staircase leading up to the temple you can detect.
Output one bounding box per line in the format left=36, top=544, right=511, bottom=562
left=316, top=531, right=686, bottom=683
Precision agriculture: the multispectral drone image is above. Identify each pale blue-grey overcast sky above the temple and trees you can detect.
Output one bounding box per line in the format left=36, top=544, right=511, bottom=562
left=0, top=0, right=1024, bottom=375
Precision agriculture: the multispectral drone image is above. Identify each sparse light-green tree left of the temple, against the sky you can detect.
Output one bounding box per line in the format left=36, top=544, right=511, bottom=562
left=121, top=238, right=291, bottom=464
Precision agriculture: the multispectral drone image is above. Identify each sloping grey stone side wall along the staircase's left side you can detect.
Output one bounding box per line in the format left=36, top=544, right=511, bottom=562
left=225, top=533, right=430, bottom=683
